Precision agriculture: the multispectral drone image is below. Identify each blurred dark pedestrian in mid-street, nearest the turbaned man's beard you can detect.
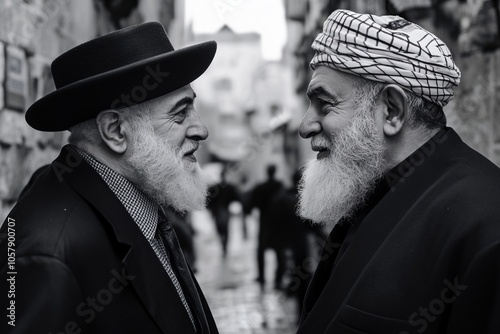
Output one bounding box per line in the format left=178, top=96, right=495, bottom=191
left=250, top=164, right=285, bottom=289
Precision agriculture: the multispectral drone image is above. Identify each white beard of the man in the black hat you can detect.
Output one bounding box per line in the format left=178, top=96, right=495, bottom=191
left=127, top=120, right=207, bottom=213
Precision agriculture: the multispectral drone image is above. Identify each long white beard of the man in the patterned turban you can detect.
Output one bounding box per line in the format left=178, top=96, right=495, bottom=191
left=298, top=110, right=384, bottom=228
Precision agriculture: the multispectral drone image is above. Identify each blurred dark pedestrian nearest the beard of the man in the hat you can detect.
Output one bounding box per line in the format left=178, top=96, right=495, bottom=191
left=207, top=167, right=241, bottom=257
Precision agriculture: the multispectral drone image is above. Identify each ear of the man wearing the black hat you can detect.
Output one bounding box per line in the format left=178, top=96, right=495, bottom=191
left=96, top=109, right=127, bottom=153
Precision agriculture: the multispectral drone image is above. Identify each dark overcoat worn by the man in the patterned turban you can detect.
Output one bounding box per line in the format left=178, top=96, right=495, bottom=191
left=298, top=128, right=500, bottom=334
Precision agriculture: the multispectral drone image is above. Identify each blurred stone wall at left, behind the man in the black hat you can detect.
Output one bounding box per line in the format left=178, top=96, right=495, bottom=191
left=0, top=0, right=74, bottom=224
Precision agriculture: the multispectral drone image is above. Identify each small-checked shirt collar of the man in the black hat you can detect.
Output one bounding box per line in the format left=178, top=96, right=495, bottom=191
left=71, top=145, right=159, bottom=240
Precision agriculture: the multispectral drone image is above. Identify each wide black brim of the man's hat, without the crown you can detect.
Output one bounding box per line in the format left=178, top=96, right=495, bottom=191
left=26, top=41, right=217, bottom=131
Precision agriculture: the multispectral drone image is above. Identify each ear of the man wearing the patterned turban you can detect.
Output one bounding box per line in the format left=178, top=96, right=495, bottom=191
left=381, top=84, right=408, bottom=137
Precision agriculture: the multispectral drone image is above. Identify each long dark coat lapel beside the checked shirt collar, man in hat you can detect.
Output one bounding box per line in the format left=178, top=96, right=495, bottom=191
left=52, top=146, right=199, bottom=333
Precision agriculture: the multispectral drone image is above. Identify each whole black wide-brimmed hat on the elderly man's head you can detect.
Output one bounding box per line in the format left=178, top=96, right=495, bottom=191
left=26, top=22, right=217, bottom=131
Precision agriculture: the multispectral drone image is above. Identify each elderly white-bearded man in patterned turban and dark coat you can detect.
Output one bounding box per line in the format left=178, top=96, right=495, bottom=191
left=298, top=10, right=500, bottom=334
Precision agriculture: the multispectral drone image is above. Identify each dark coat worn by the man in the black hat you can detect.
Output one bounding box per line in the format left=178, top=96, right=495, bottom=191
left=0, top=147, right=217, bottom=334
